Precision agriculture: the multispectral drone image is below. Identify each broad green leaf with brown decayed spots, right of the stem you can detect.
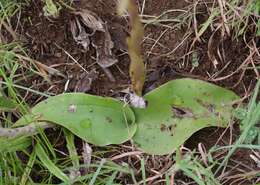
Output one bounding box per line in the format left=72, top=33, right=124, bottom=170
left=133, top=78, right=239, bottom=154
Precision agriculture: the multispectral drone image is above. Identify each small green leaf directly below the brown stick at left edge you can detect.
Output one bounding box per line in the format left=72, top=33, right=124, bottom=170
left=0, top=136, right=32, bottom=153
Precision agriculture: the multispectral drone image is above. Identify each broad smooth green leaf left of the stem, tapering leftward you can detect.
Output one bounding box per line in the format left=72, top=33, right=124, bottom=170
left=16, top=93, right=137, bottom=146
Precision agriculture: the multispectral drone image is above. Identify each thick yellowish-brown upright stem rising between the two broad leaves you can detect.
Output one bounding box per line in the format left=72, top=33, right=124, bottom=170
left=118, top=0, right=145, bottom=96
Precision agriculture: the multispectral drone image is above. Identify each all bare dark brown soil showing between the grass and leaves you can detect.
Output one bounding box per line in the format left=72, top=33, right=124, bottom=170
left=5, top=0, right=256, bottom=184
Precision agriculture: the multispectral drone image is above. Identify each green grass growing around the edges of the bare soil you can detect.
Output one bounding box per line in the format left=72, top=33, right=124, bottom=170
left=0, top=0, right=260, bottom=185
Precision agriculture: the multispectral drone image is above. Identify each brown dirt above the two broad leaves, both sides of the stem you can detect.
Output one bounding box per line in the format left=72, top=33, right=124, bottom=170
left=20, top=0, right=255, bottom=96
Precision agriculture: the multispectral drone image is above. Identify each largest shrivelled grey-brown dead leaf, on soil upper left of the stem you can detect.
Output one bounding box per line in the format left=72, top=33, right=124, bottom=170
left=71, top=9, right=118, bottom=78
